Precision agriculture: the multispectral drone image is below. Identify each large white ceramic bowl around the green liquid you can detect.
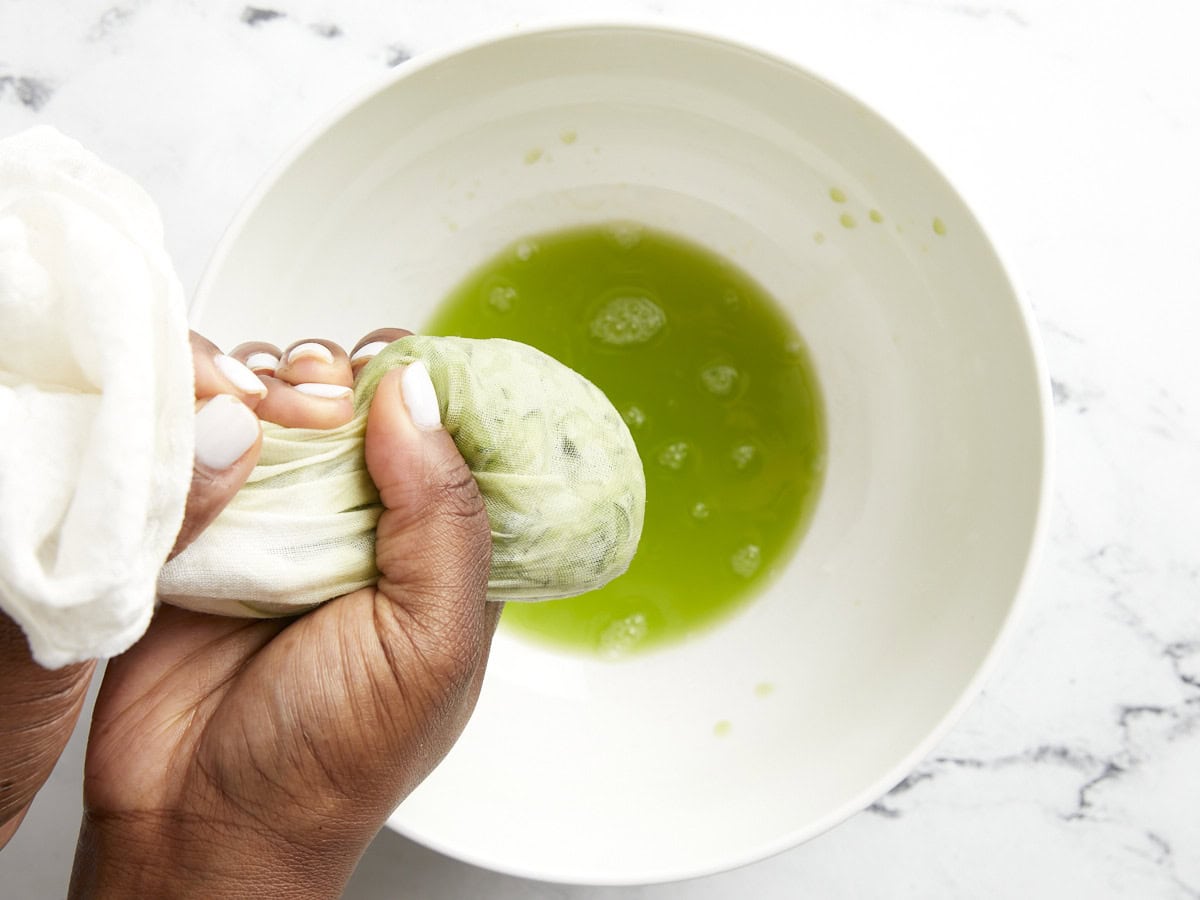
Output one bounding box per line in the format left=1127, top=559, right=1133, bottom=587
left=193, top=26, right=1048, bottom=883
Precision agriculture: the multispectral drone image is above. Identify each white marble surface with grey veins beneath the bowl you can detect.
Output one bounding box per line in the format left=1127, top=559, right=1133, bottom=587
left=0, top=0, right=1200, bottom=900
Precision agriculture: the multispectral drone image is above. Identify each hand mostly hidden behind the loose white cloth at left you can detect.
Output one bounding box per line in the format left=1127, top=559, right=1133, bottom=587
left=0, top=332, right=268, bottom=847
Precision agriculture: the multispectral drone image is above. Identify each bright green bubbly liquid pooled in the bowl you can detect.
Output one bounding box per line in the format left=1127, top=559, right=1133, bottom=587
left=426, top=223, right=824, bottom=656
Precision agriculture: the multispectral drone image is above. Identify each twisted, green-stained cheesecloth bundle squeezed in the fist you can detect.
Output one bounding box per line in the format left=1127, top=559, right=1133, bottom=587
left=158, top=335, right=646, bottom=617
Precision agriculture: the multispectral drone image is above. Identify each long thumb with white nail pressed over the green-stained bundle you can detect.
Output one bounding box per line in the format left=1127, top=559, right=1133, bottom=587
left=366, top=361, right=492, bottom=653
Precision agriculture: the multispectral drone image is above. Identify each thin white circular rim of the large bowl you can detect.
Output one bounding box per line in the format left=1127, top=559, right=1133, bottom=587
left=188, top=16, right=1054, bottom=887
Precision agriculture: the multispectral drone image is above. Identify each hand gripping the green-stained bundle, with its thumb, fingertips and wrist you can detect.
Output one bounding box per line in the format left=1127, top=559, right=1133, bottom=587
left=72, top=330, right=499, bottom=898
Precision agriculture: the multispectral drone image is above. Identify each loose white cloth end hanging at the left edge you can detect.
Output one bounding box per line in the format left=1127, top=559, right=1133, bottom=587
left=0, top=126, right=193, bottom=667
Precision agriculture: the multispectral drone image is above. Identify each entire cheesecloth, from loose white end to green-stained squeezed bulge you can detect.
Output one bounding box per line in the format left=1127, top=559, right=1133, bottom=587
left=0, top=126, right=644, bottom=667
